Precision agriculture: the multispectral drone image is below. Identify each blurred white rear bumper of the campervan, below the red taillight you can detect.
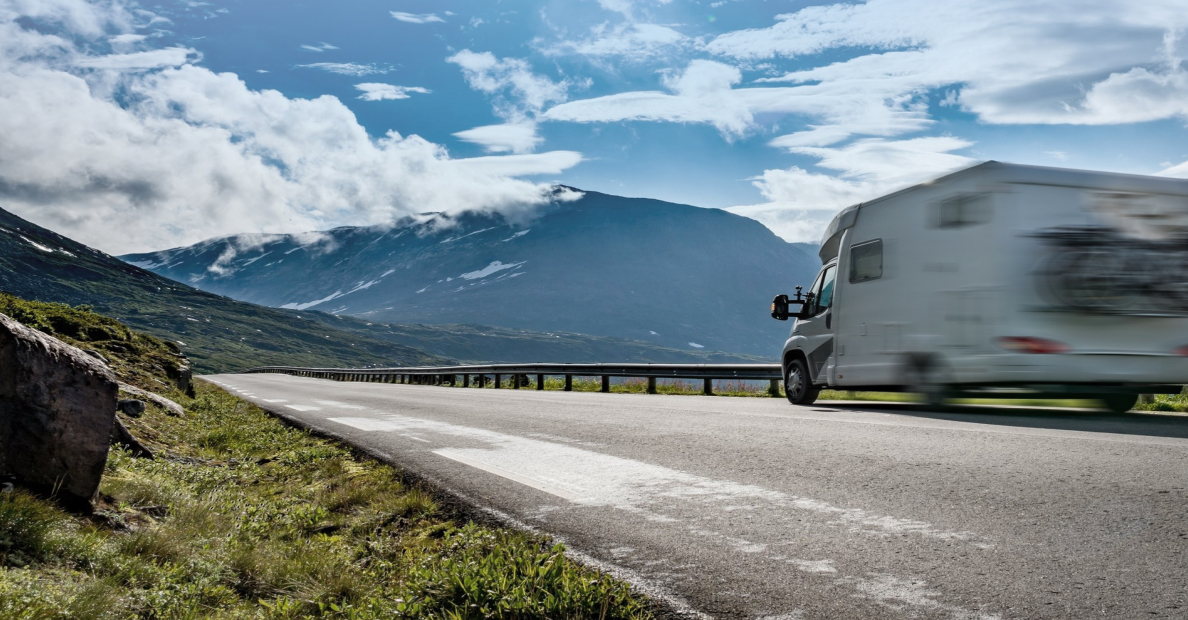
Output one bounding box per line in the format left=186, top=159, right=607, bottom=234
left=953, top=352, right=1188, bottom=386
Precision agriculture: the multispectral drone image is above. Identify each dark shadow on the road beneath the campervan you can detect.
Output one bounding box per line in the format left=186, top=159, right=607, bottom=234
left=813, top=401, right=1188, bottom=439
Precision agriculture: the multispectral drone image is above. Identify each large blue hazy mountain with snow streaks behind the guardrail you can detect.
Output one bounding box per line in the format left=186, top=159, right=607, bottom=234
left=121, top=188, right=820, bottom=359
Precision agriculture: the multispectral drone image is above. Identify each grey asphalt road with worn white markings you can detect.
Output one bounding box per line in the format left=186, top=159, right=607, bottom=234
left=207, top=374, right=1188, bottom=620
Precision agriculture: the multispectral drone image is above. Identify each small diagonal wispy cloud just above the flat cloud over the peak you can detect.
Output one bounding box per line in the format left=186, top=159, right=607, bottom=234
left=446, top=50, right=569, bottom=122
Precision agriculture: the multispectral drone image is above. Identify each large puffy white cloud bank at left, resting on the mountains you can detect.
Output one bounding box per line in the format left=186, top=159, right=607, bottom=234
left=0, top=0, right=581, bottom=253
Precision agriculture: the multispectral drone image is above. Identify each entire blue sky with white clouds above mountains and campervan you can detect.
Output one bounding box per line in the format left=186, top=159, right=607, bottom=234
left=0, top=0, right=1188, bottom=253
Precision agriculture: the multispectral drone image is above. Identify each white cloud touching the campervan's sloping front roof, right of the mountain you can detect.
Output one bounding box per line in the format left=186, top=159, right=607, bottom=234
left=728, top=137, right=974, bottom=242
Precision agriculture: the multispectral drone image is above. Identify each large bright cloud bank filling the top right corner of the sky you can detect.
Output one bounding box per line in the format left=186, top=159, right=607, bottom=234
left=707, top=0, right=1188, bottom=125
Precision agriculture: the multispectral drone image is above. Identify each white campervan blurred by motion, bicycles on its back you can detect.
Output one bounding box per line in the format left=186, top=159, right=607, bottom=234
left=772, top=162, right=1188, bottom=411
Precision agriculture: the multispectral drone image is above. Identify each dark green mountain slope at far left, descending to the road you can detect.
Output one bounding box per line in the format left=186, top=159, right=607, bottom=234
left=0, top=209, right=449, bottom=373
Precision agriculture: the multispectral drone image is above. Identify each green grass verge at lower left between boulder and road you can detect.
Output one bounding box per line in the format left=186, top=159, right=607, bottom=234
left=0, top=382, right=650, bottom=619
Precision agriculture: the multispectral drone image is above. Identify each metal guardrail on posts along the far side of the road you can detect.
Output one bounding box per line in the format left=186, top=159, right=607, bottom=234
left=241, top=363, right=783, bottom=396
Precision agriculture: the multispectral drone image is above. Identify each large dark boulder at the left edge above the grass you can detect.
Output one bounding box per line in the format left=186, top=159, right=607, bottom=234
left=0, top=315, right=119, bottom=510
